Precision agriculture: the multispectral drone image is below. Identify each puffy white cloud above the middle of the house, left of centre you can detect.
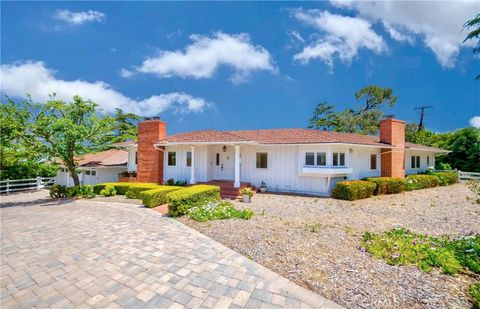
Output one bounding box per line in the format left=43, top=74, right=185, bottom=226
left=131, top=32, right=276, bottom=82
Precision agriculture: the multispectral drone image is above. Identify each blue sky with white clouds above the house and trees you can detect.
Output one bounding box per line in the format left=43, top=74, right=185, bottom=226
left=1, top=1, right=480, bottom=133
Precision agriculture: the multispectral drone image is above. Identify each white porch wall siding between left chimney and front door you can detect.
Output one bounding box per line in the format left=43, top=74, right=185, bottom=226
left=164, top=145, right=208, bottom=182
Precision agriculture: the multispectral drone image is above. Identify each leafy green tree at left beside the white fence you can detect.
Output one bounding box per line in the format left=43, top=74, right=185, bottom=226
left=2, top=95, right=115, bottom=185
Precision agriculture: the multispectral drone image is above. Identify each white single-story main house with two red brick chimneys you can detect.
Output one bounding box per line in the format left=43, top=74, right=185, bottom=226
left=108, top=117, right=447, bottom=195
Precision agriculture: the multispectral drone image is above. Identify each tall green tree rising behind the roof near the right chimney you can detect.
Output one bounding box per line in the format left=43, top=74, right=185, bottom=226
left=308, top=85, right=397, bottom=134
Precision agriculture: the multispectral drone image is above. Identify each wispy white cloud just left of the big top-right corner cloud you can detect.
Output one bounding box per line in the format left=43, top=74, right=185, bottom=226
left=292, top=8, right=387, bottom=68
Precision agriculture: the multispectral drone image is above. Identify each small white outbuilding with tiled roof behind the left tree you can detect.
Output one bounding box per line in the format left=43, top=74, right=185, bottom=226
left=55, top=149, right=129, bottom=186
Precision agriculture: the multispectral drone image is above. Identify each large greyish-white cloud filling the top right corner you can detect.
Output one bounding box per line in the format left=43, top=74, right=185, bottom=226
left=331, top=0, right=480, bottom=68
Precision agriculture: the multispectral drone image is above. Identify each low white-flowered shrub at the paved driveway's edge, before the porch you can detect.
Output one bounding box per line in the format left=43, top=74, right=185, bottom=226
left=187, top=201, right=253, bottom=222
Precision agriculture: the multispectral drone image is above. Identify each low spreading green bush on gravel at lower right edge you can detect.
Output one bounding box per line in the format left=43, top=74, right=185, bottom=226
left=363, top=228, right=480, bottom=274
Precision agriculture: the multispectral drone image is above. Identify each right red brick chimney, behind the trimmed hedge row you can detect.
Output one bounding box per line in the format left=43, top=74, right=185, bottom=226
left=380, top=116, right=405, bottom=178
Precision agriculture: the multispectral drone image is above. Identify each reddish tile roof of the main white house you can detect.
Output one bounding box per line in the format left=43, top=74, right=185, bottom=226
left=159, top=129, right=443, bottom=151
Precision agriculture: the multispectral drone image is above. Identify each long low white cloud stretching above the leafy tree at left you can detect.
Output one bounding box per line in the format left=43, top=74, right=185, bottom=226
left=0, top=61, right=210, bottom=116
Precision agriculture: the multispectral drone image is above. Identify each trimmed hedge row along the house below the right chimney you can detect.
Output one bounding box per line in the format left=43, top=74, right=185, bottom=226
left=332, top=172, right=458, bottom=201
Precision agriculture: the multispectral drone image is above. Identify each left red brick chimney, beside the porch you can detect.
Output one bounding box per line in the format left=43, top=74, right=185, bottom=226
left=137, top=117, right=167, bottom=183
